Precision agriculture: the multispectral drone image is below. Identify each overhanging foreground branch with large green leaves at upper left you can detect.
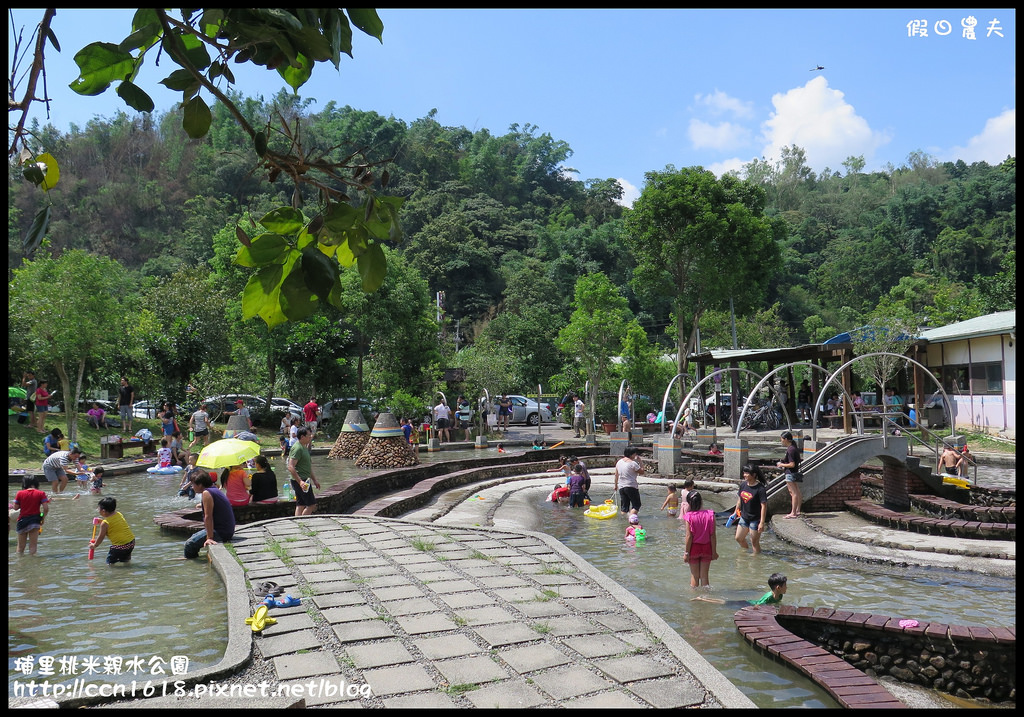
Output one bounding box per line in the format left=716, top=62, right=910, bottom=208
left=8, top=7, right=401, bottom=327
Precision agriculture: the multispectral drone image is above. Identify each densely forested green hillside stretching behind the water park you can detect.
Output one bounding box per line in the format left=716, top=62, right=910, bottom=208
left=8, top=93, right=1016, bottom=413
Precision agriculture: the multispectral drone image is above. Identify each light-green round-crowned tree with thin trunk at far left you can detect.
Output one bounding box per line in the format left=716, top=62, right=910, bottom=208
left=7, top=251, right=128, bottom=440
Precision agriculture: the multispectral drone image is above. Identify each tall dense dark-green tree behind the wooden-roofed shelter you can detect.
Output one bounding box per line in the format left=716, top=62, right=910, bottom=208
left=624, top=167, right=778, bottom=383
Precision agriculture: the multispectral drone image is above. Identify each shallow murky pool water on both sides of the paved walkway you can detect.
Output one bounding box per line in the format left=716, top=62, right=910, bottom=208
left=8, top=450, right=1016, bottom=707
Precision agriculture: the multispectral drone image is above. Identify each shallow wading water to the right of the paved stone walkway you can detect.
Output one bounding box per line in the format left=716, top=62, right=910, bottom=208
left=528, top=486, right=1016, bottom=707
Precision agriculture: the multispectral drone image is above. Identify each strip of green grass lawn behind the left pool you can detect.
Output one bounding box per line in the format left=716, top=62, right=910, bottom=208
left=7, top=413, right=281, bottom=470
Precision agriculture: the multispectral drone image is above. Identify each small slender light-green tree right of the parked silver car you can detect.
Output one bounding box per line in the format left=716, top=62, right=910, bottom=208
left=555, top=273, right=632, bottom=422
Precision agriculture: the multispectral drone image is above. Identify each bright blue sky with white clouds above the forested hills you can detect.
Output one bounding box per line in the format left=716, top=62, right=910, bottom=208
left=8, top=7, right=1016, bottom=204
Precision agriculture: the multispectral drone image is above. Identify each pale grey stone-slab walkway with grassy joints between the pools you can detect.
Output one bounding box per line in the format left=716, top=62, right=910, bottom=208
left=209, top=516, right=753, bottom=708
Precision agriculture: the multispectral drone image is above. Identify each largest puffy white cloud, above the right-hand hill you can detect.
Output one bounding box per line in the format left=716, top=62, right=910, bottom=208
left=761, top=76, right=890, bottom=171
